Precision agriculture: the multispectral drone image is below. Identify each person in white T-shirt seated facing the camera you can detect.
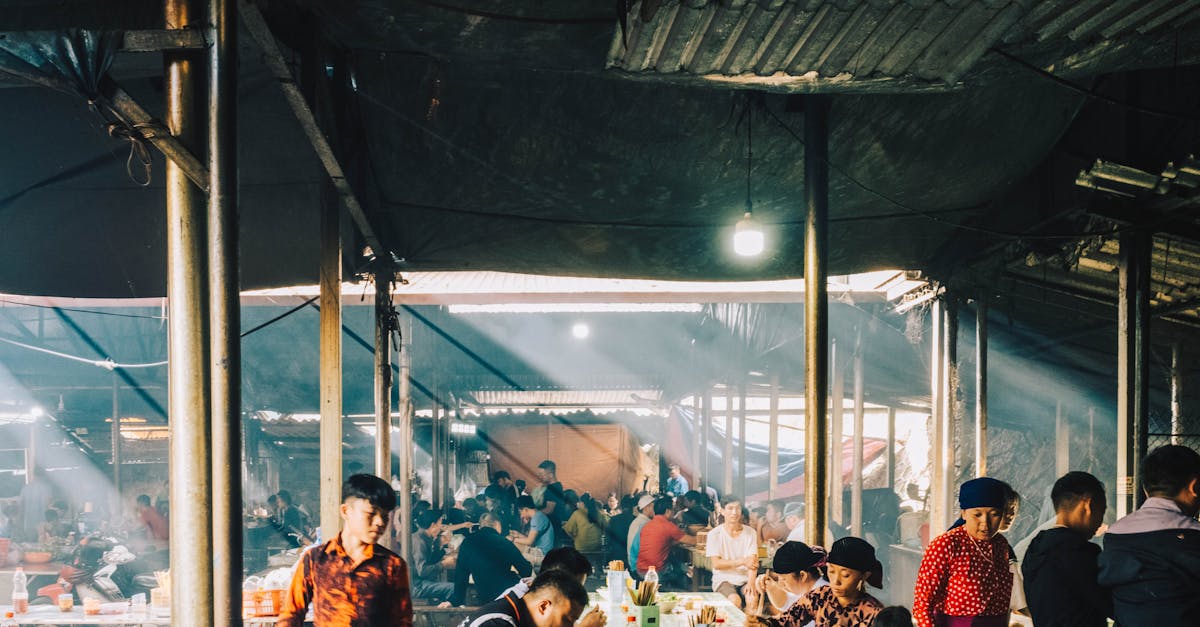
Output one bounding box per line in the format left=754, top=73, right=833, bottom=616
left=704, top=496, right=758, bottom=608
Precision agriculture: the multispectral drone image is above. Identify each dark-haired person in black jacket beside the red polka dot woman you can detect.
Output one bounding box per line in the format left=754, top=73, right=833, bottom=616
left=1021, top=471, right=1112, bottom=627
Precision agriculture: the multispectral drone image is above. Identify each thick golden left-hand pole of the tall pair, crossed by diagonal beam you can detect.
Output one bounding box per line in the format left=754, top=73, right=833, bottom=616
left=163, top=0, right=215, bottom=627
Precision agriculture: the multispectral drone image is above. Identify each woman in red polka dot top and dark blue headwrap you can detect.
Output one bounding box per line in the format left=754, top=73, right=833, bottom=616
left=912, top=477, right=1013, bottom=627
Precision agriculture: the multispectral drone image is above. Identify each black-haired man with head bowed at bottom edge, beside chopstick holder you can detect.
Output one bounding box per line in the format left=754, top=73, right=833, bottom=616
left=458, top=569, right=588, bottom=627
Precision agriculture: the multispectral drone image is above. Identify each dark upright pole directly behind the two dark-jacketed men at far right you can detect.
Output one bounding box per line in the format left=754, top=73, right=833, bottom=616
left=1116, top=229, right=1152, bottom=516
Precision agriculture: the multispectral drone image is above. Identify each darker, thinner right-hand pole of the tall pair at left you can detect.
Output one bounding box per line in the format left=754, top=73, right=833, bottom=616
left=208, top=0, right=242, bottom=627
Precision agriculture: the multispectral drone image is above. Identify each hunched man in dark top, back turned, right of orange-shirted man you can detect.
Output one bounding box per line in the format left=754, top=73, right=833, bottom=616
left=446, top=513, right=533, bottom=605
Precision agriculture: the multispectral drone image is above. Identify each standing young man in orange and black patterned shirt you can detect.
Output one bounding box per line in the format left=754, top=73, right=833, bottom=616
left=276, top=474, right=413, bottom=627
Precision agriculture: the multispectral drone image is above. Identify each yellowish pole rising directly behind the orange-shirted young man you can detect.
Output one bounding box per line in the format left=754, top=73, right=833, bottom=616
left=319, top=186, right=342, bottom=541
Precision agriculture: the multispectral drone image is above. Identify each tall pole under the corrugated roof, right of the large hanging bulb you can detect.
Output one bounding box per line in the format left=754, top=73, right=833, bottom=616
left=804, top=95, right=829, bottom=547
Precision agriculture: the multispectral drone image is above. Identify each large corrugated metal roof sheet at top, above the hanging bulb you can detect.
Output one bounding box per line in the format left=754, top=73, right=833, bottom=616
left=608, top=0, right=1200, bottom=91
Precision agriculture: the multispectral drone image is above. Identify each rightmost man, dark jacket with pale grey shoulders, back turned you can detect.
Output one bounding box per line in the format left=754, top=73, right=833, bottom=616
left=1099, top=446, right=1200, bottom=627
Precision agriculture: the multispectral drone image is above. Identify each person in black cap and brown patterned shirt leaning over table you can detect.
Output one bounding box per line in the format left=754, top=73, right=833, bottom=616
left=746, top=537, right=883, bottom=627
